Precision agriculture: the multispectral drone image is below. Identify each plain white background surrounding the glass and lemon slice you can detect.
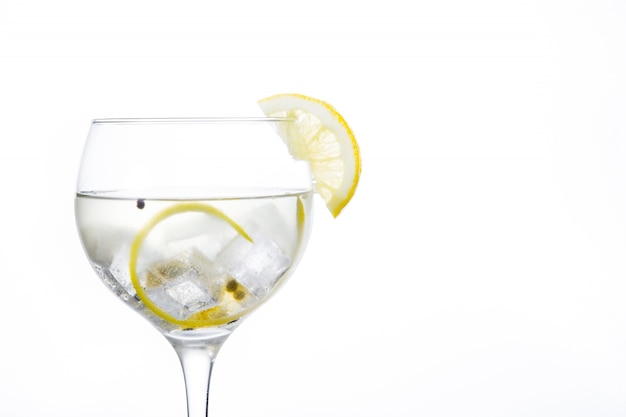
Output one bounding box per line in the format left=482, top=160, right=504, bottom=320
left=0, top=0, right=626, bottom=417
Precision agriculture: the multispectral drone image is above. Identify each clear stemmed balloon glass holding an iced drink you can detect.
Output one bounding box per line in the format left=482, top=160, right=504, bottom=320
left=75, top=118, right=313, bottom=417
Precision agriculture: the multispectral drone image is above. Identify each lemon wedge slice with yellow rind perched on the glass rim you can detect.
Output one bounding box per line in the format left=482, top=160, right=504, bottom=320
left=259, top=94, right=361, bottom=217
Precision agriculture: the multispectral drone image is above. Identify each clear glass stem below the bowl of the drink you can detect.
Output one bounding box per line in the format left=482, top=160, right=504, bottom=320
left=168, top=335, right=228, bottom=417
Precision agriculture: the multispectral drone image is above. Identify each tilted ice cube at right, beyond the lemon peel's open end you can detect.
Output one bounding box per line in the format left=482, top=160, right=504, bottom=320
left=217, top=222, right=291, bottom=297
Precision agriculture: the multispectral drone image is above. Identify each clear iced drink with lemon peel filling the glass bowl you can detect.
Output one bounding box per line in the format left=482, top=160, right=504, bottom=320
left=75, top=190, right=312, bottom=335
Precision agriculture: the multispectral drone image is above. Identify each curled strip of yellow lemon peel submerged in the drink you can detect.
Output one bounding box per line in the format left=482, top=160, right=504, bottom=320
left=129, top=202, right=252, bottom=328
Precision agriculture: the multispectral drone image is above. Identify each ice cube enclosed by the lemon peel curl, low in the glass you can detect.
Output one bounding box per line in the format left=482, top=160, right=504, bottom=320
left=142, top=249, right=229, bottom=320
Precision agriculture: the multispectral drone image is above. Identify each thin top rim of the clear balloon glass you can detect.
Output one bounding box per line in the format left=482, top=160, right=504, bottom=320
left=91, top=116, right=294, bottom=125
